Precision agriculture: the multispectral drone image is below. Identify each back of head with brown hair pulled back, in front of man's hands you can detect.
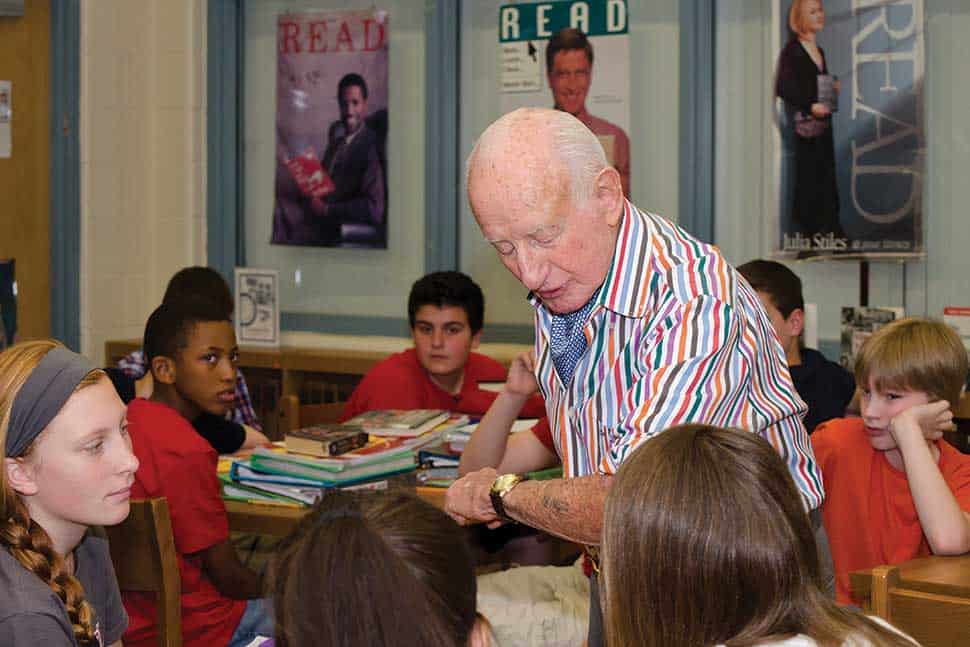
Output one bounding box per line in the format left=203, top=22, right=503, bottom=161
left=272, top=491, right=476, bottom=647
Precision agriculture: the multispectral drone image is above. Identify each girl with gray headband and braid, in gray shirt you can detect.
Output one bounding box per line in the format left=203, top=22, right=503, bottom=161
left=0, top=341, right=138, bottom=647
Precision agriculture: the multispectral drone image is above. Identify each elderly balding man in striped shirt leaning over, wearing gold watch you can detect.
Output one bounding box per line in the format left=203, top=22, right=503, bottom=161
left=446, top=108, right=824, bottom=644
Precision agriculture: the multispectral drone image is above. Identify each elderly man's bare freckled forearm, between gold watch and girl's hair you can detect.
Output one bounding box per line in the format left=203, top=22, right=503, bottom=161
left=502, top=475, right=612, bottom=545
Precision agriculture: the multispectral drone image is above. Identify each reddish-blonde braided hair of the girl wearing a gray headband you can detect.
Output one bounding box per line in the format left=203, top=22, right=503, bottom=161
left=0, top=340, right=104, bottom=645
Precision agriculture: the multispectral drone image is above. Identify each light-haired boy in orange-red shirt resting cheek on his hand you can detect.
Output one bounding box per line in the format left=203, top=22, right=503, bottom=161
left=811, top=317, right=970, bottom=605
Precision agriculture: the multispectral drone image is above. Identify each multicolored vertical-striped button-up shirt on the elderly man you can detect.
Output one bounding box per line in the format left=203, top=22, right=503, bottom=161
left=529, top=203, right=824, bottom=508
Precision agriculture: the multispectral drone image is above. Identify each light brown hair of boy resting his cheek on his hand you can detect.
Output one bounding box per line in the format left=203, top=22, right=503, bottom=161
left=855, top=317, right=967, bottom=407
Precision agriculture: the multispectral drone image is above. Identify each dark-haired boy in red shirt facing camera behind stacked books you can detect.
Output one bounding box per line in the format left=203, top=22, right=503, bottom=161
left=341, top=272, right=558, bottom=464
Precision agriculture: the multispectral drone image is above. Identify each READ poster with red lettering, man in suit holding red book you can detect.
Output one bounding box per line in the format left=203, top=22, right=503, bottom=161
left=270, top=10, right=390, bottom=248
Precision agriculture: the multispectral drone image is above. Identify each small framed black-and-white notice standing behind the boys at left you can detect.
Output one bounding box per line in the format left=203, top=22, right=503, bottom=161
left=235, top=267, right=280, bottom=346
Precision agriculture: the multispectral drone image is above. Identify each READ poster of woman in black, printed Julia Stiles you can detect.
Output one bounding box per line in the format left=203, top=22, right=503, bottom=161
left=773, top=0, right=926, bottom=258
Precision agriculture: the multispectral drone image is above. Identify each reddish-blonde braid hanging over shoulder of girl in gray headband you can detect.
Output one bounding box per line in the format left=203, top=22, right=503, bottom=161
left=0, top=496, right=97, bottom=645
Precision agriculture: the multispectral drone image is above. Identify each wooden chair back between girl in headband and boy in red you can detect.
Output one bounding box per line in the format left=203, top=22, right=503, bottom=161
left=105, top=497, right=182, bottom=647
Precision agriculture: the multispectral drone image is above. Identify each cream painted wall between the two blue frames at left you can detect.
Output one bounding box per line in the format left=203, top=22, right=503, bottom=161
left=80, top=0, right=206, bottom=362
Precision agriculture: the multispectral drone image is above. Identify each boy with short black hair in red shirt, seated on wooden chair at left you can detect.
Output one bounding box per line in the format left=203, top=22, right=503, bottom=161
left=122, top=300, right=273, bottom=647
